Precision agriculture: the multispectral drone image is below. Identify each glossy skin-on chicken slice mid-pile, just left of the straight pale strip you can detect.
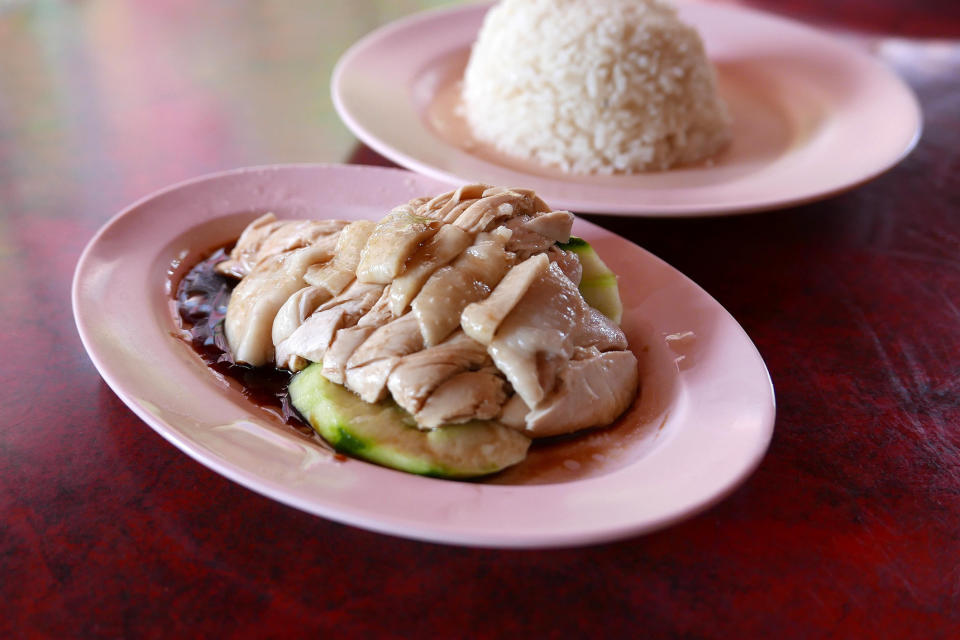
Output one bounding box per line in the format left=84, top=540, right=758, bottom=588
left=410, top=227, right=513, bottom=346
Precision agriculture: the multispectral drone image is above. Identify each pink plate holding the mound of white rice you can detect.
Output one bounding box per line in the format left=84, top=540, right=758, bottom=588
left=332, top=2, right=921, bottom=216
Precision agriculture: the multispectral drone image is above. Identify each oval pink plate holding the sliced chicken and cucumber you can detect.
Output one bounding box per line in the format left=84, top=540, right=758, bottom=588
left=73, top=165, right=774, bottom=547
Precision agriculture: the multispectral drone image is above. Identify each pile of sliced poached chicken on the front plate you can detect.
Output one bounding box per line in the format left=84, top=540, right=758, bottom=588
left=218, top=184, right=638, bottom=437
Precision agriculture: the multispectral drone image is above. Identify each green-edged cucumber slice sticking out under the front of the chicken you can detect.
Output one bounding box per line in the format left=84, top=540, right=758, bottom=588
left=289, top=364, right=530, bottom=478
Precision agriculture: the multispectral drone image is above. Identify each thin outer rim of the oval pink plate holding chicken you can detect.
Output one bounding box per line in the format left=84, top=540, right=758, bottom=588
left=71, top=163, right=776, bottom=548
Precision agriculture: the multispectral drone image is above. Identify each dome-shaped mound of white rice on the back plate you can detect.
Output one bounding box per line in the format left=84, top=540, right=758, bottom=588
left=463, top=0, right=730, bottom=173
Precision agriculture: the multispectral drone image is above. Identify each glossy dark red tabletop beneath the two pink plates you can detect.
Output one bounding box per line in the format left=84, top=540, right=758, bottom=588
left=0, top=0, right=960, bottom=638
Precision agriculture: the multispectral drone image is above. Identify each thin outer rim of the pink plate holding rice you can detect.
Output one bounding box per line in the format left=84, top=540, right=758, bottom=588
left=330, top=0, right=923, bottom=218
